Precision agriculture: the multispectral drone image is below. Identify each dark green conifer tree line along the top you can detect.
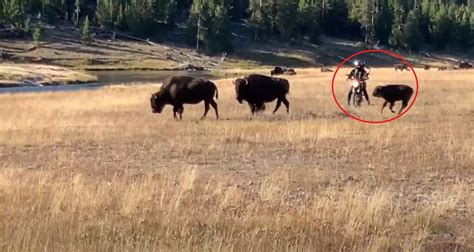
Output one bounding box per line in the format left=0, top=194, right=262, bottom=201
left=0, top=0, right=474, bottom=53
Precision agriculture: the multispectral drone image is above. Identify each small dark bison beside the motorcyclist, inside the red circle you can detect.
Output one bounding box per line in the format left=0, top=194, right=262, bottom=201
left=372, top=85, right=413, bottom=114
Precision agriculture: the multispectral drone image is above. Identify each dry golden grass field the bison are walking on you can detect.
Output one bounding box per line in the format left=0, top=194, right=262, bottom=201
left=0, top=69, right=474, bottom=251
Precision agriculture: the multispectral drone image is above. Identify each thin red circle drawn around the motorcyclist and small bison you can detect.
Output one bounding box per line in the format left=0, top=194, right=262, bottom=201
left=332, top=50, right=418, bottom=124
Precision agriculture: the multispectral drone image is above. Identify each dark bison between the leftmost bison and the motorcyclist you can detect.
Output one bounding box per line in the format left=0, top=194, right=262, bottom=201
left=234, top=74, right=290, bottom=114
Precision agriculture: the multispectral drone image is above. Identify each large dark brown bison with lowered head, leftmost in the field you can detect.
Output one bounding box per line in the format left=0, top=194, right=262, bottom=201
left=150, top=76, right=219, bottom=120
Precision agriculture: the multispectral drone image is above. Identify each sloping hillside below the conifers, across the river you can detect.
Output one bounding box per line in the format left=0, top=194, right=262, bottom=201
left=0, top=23, right=472, bottom=70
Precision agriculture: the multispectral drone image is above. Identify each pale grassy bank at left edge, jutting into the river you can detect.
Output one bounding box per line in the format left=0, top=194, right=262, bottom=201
left=0, top=63, right=97, bottom=88
